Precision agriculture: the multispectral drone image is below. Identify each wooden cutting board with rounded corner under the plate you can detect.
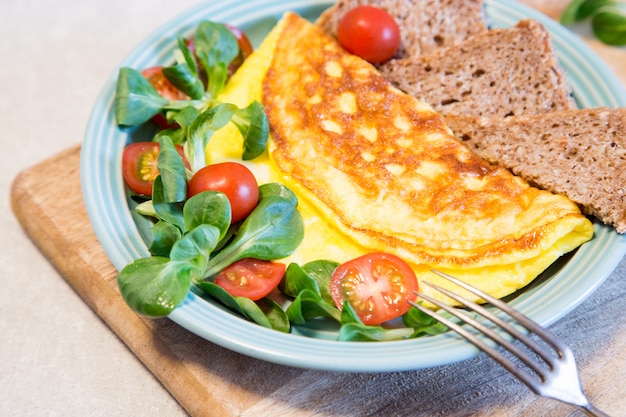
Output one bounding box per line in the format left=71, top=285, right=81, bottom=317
left=11, top=146, right=626, bottom=417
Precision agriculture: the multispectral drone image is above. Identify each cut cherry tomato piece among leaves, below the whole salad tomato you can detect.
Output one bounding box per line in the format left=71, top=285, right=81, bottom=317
left=214, top=258, right=287, bottom=301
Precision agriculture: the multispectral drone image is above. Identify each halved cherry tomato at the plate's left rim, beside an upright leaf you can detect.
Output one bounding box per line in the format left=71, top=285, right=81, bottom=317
left=122, top=142, right=189, bottom=196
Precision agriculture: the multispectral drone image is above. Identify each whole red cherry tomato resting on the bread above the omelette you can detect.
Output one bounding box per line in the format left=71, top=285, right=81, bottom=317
left=337, top=6, right=400, bottom=64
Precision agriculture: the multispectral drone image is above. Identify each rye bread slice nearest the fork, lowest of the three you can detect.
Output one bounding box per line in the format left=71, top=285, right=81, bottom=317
left=446, top=107, right=626, bottom=233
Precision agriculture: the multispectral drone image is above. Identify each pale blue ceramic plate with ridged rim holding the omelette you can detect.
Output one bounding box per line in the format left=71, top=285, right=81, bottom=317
left=81, top=0, right=626, bottom=371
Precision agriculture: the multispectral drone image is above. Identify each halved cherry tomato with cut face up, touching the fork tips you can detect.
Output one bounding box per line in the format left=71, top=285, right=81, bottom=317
left=330, top=252, right=418, bottom=325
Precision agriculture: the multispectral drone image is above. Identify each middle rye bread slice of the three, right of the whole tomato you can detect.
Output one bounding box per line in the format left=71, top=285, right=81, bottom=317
left=380, top=19, right=576, bottom=116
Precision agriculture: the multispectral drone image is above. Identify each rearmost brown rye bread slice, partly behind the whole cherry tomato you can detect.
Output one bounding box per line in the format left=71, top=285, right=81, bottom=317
left=315, top=0, right=487, bottom=61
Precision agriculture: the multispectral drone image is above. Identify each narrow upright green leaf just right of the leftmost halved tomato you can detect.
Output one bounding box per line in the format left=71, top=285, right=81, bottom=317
left=158, top=136, right=187, bottom=203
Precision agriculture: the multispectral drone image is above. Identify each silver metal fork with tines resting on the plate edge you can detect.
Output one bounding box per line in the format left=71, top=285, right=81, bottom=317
left=412, top=270, right=608, bottom=417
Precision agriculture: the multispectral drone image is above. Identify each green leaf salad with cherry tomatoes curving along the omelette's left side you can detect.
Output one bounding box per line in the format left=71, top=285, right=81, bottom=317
left=115, top=17, right=446, bottom=340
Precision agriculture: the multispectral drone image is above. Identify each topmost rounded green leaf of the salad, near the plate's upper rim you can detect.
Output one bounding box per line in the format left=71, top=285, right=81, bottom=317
left=194, top=21, right=239, bottom=98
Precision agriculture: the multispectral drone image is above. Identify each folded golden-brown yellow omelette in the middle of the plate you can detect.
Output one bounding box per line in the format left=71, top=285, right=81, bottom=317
left=206, top=13, right=593, bottom=298
